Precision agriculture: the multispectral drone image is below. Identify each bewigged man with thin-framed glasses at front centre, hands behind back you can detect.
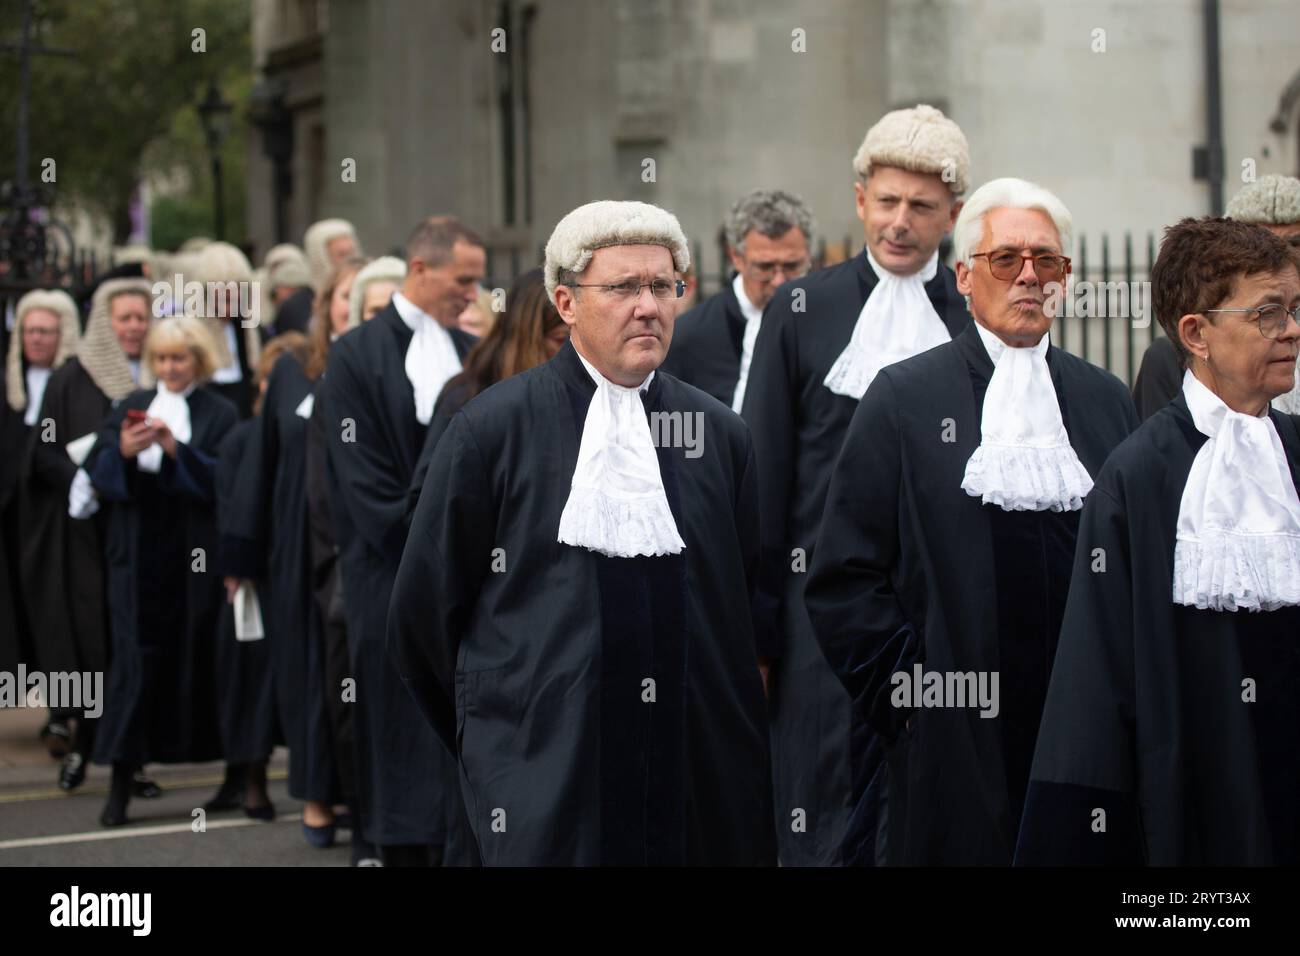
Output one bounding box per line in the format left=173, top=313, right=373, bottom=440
left=389, top=202, right=775, bottom=865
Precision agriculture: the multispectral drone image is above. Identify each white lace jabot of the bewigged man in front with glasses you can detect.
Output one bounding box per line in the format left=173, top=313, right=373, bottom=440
left=558, top=349, right=686, bottom=558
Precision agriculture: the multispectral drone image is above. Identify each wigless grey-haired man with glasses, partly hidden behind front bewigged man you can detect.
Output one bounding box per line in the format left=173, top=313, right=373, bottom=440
left=663, top=189, right=814, bottom=412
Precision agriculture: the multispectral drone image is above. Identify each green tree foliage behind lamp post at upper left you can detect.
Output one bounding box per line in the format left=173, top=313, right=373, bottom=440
left=0, top=0, right=251, bottom=246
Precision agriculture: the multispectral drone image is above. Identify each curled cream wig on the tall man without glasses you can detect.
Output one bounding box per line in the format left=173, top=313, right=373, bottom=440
left=853, top=103, right=971, bottom=196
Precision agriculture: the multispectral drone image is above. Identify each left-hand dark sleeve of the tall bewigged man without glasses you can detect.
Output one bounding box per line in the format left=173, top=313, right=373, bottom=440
left=741, top=303, right=800, bottom=658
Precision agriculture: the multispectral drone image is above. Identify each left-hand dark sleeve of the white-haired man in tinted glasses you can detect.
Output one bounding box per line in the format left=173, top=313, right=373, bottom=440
left=803, top=375, right=924, bottom=743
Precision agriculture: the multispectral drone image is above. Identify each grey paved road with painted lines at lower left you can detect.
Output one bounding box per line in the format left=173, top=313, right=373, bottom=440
left=0, top=708, right=348, bottom=866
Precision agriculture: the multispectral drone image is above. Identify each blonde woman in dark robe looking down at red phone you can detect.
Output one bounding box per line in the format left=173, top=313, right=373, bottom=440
left=85, top=316, right=238, bottom=826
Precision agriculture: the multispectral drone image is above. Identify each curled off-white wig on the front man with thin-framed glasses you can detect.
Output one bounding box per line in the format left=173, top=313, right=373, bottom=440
left=546, top=199, right=690, bottom=306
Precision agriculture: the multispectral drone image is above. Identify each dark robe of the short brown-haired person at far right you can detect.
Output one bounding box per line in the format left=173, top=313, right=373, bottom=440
left=1017, top=394, right=1300, bottom=866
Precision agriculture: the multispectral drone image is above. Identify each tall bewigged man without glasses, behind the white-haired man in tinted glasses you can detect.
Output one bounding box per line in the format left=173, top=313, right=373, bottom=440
left=741, top=105, right=970, bottom=866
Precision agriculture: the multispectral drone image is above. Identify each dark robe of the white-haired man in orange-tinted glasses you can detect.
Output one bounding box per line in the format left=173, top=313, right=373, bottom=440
left=805, top=324, right=1138, bottom=865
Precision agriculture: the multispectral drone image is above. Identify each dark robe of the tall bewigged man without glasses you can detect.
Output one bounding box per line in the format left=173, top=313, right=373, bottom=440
left=741, top=250, right=971, bottom=866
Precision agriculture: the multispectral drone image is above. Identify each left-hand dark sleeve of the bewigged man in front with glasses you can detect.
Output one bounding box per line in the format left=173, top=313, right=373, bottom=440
left=387, top=415, right=497, bottom=754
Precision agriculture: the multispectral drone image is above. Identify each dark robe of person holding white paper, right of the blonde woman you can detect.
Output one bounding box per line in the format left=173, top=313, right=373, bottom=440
left=213, top=418, right=278, bottom=763
